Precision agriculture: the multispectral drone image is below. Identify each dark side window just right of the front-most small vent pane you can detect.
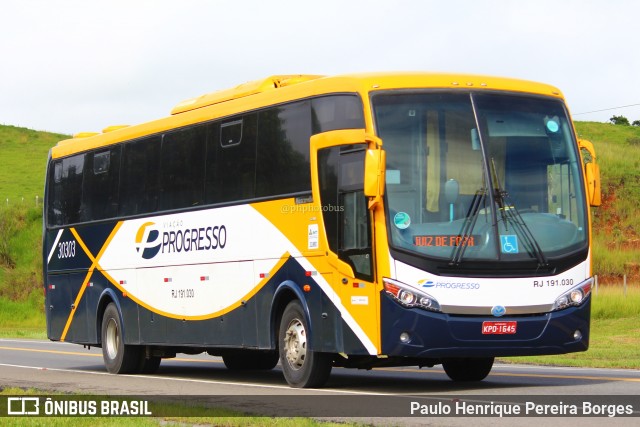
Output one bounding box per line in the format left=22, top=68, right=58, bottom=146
left=256, top=101, right=311, bottom=197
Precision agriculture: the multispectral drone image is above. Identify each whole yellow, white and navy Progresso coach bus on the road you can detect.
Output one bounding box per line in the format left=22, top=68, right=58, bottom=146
left=43, top=73, right=599, bottom=387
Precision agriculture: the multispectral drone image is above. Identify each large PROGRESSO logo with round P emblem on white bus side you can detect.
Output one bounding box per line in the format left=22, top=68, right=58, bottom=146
left=135, top=222, right=227, bottom=259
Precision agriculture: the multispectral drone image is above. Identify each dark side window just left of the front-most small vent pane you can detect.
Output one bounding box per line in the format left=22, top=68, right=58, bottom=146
left=160, top=126, right=206, bottom=210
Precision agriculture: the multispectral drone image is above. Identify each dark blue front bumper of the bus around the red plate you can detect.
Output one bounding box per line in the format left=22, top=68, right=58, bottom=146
left=381, top=292, right=591, bottom=359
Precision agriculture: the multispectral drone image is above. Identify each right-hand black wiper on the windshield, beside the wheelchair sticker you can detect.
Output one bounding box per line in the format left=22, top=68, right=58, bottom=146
left=491, top=158, right=549, bottom=267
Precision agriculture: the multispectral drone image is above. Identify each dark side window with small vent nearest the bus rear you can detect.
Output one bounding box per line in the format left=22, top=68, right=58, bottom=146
left=81, top=146, right=120, bottom=221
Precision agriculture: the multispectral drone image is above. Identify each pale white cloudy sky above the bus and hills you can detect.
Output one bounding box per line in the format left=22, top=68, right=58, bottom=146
left=0, top=0, right=640, bottom=134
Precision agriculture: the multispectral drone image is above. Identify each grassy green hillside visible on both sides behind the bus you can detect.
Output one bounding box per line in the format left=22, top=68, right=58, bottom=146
left=0, top=122, right=640, bottom=308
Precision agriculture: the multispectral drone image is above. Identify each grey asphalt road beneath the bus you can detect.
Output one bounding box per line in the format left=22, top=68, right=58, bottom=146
left=0, top=339, right=640, bottom=426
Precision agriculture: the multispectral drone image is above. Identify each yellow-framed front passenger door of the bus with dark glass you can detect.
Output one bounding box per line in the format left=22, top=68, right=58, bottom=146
left=311, top=130, right=380, bottom=354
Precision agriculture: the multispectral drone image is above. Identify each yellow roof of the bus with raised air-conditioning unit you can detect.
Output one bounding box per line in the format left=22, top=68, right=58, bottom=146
left=51, top=73, right=562, bottom=159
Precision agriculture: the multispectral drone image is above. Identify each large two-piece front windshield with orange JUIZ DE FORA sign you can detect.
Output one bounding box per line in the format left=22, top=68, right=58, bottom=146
left=372, top=91, right=587, bottom=265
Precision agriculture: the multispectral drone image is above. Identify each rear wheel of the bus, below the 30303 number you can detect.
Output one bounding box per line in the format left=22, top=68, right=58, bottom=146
left=102, top=303, right=142, bottom=374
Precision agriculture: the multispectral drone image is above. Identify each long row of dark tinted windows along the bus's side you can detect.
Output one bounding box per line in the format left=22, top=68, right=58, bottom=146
left=47, top=95, right=364, bottom=227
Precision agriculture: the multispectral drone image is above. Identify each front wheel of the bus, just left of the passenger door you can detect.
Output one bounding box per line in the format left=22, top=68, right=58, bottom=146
left=278, top=301, right=333, bottom=388
